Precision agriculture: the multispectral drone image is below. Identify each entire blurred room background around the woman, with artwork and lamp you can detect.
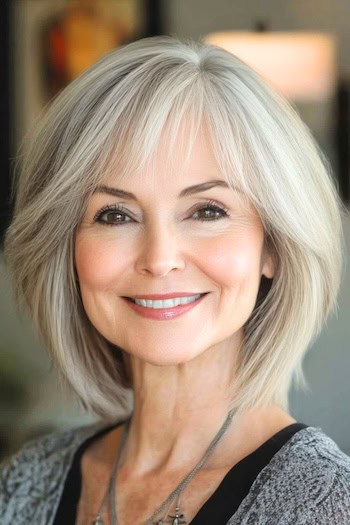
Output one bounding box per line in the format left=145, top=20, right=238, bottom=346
left=0, top=0, right=350, bottom=459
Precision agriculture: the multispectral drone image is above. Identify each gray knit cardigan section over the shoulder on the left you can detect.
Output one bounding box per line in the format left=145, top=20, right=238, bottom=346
left=0, top=423, right=104, bottom=525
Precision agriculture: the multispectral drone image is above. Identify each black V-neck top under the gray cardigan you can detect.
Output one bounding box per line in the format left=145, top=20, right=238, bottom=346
left=53, top=423, right=308, bottom=525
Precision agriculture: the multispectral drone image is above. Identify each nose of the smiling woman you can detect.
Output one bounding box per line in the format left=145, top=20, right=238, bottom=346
left=136, top=223, right=185, bottom=277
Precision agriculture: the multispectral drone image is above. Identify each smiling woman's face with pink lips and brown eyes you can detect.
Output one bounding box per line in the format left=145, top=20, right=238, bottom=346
left=75, top=129, right=274, bottom=365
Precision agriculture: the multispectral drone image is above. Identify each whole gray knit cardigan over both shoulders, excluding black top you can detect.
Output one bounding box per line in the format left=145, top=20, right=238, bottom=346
left=0, top=424, right=350, bottom=525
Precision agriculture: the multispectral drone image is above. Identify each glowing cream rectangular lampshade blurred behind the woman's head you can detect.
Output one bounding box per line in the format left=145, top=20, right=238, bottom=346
left=204, top=31, right=337, bottom=101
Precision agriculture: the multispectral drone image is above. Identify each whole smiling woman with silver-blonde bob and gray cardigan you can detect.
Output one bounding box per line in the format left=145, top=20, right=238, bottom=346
left=0, top=36, right=350, bottom=525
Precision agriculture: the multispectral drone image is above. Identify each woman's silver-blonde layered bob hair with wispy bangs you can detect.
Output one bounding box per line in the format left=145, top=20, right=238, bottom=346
left=5, top=36, right=342, bottom=420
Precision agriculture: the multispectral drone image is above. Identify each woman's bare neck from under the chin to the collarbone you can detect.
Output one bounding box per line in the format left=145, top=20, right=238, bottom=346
left=119, top=340, right=237, bottom=475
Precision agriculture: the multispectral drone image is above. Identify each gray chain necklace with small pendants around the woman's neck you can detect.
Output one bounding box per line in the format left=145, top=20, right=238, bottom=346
left=92, top=409, right=235, bottom=525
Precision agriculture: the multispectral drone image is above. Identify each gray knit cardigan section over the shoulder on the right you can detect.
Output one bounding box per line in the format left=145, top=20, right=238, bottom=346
left=230, top=427, right=350, bottom=525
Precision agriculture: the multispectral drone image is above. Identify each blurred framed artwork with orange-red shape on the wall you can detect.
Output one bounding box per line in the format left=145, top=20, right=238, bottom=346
left=41, top=0, right=154, bottom=98
